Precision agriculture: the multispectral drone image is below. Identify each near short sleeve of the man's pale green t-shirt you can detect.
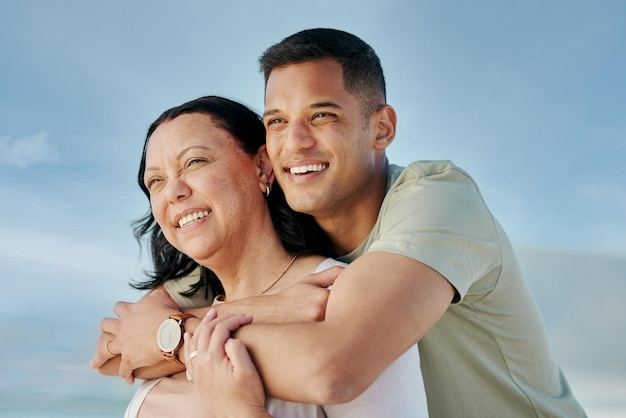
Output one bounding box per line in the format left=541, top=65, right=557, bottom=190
left=367, top=163, right=502, bottom=302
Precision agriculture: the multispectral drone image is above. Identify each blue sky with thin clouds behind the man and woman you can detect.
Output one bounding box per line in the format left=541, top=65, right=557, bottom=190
left=0, top=0, right=626, bottom=416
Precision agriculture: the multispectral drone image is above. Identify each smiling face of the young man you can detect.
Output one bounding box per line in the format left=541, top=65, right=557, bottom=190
left=264, top=60, right=380, bottom=218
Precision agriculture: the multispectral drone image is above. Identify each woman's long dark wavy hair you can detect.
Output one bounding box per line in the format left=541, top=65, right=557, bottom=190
left=131, top=96, right=331, bottom=296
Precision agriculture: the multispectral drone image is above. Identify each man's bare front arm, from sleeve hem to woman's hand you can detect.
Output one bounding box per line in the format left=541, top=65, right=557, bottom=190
left=236, top=252, right=455, bottom=404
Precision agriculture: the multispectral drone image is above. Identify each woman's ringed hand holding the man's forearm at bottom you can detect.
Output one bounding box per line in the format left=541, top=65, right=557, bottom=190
left=180, top=309, right=270, bottom=418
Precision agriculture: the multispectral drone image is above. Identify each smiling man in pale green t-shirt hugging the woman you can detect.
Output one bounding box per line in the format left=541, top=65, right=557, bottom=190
left=95, top=29, right=585, bottom=417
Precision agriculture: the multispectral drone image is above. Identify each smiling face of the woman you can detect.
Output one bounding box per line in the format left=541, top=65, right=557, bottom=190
left=144, top=113, right=267, bottom=262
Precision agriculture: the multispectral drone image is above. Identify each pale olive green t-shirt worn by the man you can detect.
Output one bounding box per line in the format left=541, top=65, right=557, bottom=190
left=339, top=161, right=585, bottom=418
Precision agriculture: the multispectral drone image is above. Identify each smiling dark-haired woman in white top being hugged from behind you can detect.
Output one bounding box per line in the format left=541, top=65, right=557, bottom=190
left=127, top=96, right=426, bottom=417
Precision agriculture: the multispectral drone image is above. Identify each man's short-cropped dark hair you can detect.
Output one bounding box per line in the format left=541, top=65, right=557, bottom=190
left=259, top=28, right=387, bottom=117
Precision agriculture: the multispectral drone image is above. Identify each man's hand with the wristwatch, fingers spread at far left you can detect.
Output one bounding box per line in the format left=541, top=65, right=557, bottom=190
left=89, top=287, right=179, bottom=384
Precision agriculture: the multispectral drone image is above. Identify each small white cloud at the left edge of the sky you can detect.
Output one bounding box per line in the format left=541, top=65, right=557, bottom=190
left=0, top=132, right=59, bottom=168
